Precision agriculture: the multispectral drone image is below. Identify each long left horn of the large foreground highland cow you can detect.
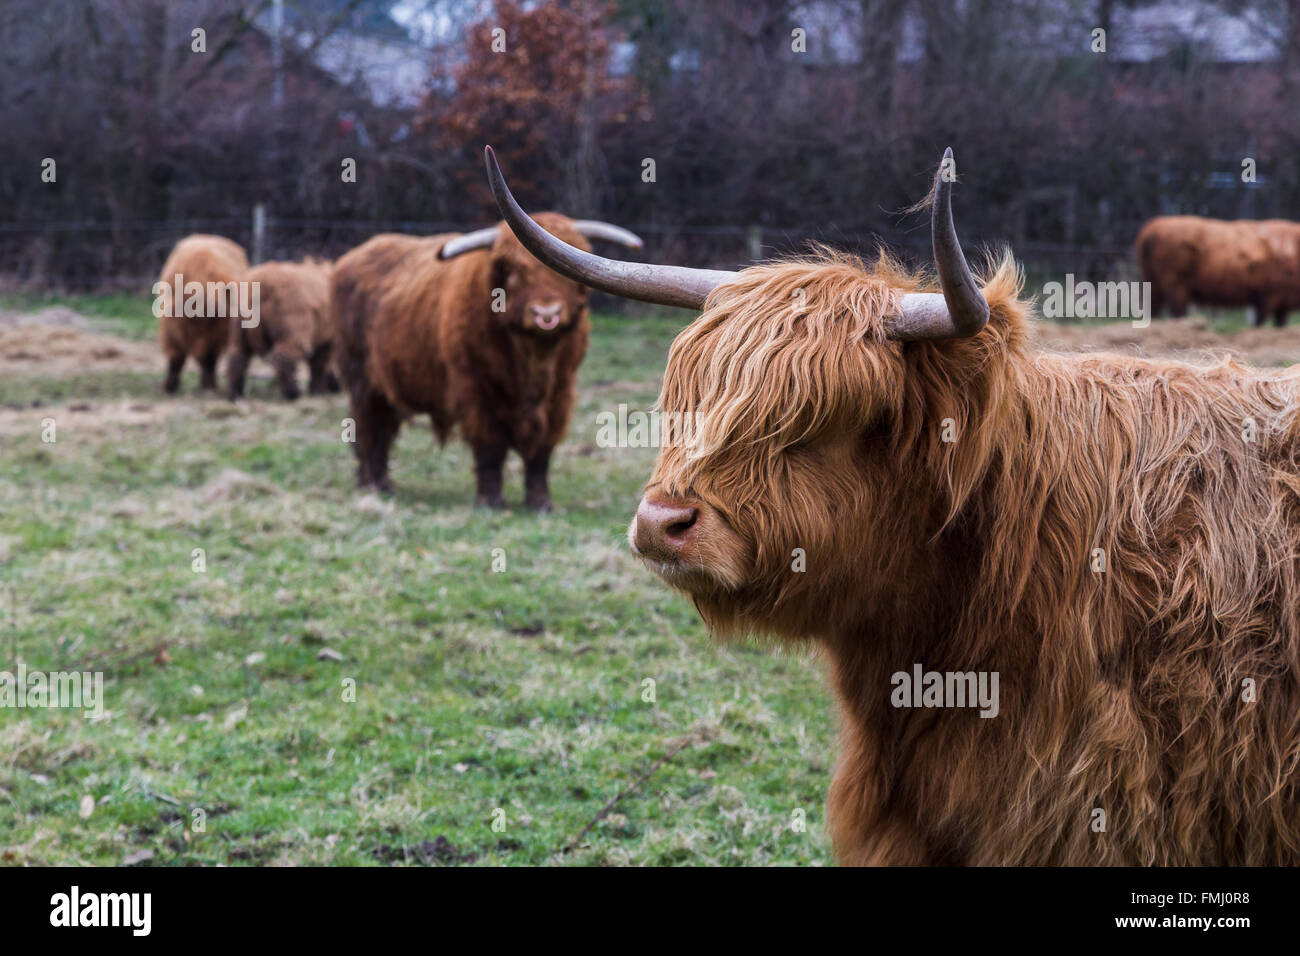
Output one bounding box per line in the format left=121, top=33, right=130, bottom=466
left=484, top=146, right=736, bottom=310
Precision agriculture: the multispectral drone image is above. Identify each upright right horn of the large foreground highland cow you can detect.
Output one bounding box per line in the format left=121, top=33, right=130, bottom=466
left=891, top=147, right=988, bottom=342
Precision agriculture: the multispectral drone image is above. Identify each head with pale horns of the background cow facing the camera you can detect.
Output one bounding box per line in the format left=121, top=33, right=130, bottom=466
left=438, top=212, right=641, bottom=341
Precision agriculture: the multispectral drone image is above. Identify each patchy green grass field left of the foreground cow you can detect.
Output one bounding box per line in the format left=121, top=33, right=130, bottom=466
left=0, top=297, right=835, bottom=865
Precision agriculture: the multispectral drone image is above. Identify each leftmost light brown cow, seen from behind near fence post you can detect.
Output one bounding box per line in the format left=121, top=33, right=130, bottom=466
left=155, top=234, right=248, bottom=394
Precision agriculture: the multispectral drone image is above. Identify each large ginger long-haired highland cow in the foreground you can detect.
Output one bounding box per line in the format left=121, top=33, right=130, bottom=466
left=489, top=147, right=1300, bottom=865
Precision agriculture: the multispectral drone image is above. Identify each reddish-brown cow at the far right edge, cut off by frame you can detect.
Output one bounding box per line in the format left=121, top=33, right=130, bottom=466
left=1134, top=216, right=1300, bottom=328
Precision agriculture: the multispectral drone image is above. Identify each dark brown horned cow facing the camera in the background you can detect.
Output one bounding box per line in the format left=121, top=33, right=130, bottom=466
left=332, top=213, right=641, bottom=510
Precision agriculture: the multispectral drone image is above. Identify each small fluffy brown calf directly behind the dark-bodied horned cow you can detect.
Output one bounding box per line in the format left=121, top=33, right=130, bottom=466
left=226, top=259, right=338, bottom=401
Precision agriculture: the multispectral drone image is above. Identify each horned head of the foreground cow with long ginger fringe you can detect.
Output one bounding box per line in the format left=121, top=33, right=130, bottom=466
left=489, top=145, right=1023, bottom=636
